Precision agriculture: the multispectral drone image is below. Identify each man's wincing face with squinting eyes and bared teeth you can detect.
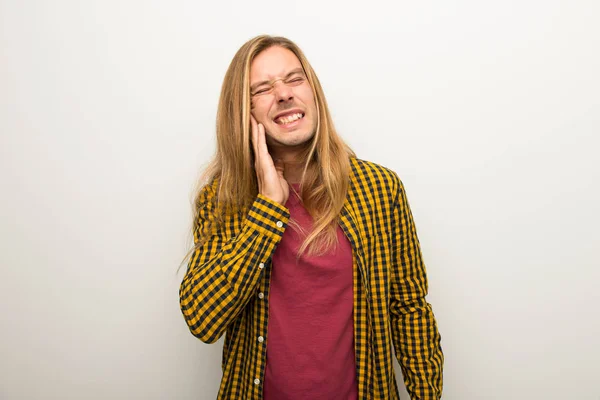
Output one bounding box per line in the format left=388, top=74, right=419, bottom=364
left=250, top=46, right=317, bottom=152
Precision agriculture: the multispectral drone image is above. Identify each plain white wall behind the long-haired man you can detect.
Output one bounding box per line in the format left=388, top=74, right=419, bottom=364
left=0, top=0, right=600, bottom=400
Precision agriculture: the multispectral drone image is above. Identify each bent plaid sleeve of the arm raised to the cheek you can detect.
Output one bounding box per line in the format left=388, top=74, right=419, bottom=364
left=179, top=185, right=289, bottom=343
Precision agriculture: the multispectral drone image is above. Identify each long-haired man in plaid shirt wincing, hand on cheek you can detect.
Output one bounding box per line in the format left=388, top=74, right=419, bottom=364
left=180, top=36, right=443, bottom=400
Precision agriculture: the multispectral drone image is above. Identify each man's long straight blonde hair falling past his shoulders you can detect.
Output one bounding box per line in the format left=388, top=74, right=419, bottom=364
left=194, top=35, right=354, bottom=255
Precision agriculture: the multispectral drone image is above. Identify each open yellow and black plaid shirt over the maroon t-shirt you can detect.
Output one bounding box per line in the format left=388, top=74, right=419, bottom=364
left=179, top=158, right=444, bottom=400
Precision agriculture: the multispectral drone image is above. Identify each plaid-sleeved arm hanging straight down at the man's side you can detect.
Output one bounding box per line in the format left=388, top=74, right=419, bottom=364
left=390, top=180, right=444, bottom=400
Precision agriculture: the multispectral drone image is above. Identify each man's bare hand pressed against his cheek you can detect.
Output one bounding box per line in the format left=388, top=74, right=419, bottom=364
left=250, top=115, right=290, bottom=205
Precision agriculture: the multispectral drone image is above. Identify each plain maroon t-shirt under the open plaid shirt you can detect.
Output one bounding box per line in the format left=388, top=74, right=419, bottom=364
left=263, top=186, right=358, bottom=400
